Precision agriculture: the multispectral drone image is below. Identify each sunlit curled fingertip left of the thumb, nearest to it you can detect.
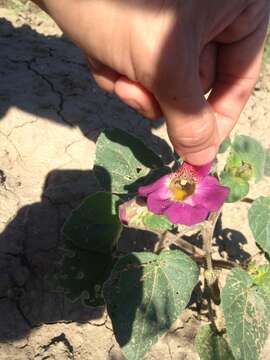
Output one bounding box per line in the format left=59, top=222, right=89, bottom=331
left=114, top=76, right=162, bottom=120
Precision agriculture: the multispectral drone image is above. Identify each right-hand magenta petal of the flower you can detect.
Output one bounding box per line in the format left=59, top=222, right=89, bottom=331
left=190, top=176, right=230, bottom=211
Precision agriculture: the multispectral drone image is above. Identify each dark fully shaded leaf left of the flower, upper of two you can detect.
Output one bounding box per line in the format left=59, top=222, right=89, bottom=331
left=63, top=192, right=122, bottom=253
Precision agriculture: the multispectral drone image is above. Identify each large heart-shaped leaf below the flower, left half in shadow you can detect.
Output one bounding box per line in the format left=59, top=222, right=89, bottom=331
left=104, top=251, right=199, bottom=360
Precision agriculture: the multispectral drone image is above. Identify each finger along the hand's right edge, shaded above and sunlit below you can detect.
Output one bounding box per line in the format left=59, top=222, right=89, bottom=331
left=208, top=20, right=267, bottom=141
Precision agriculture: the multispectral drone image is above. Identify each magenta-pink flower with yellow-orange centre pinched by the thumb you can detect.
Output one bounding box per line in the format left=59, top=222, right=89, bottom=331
left=138, top=163, right=230, bottom=226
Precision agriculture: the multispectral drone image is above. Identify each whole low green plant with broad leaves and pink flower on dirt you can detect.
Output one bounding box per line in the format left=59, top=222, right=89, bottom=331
left=57, top=129, right=270, bottom=360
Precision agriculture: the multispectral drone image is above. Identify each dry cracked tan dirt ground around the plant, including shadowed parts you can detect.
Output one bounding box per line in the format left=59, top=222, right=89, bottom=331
left=0, top=7, right=270, bottom=360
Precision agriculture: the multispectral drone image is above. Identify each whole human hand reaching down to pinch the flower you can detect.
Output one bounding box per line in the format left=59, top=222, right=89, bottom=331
left=35, top=0, right=270, bottom=165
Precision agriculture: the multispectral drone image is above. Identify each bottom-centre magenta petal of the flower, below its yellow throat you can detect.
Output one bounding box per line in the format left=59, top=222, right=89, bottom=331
left=164, top=202, right=208, bottom=226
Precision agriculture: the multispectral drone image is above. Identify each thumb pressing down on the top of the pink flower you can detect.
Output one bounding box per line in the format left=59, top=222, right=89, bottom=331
left=155, top=45, right=220, bottom=165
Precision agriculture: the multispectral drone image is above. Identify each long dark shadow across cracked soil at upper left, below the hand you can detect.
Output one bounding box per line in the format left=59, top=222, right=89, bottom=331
left=0, top=18, right=173, bottom=161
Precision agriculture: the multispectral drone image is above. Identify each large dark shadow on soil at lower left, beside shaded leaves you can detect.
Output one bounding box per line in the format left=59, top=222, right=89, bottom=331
left=0, top=166, right=160, bottom=341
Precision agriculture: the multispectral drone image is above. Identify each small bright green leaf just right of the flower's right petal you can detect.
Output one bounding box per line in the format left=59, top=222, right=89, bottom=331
left=220, top=171, right=249, bottom=203
